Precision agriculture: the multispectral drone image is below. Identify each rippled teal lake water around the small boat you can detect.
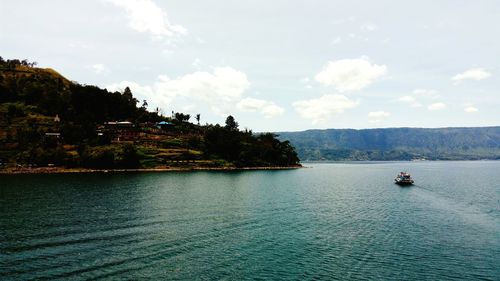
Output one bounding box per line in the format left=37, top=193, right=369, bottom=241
left=0, top=162, right=500, bottom=280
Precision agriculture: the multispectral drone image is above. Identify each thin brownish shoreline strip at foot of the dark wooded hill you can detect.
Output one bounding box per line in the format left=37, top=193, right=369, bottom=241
left=0, top=166, right=303, bottom=175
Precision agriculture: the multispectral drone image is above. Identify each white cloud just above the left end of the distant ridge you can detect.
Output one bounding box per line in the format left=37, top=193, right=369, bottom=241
left=293, top=95, right=359, bottom=124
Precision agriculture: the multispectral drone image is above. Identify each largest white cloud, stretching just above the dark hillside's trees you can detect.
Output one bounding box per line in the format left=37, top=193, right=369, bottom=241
left=106, top=66, right=250, bottom=115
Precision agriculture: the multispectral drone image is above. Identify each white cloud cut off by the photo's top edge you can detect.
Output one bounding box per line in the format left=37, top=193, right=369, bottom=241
left=106, top=0, right=187, bottom=39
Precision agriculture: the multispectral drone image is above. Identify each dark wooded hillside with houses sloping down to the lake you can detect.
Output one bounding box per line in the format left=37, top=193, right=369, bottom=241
left=0, top=57, right=300, bottom=168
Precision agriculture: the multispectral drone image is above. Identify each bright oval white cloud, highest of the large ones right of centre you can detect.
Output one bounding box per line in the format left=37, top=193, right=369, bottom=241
left=315, top=57, right=387, bottom=92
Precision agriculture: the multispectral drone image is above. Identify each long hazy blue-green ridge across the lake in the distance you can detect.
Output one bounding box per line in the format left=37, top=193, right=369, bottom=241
left=279, top=127, right=500, bottom=161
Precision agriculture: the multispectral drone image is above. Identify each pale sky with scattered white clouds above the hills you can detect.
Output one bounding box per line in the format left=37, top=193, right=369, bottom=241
left=0, top=0, right=500, bottom=132
